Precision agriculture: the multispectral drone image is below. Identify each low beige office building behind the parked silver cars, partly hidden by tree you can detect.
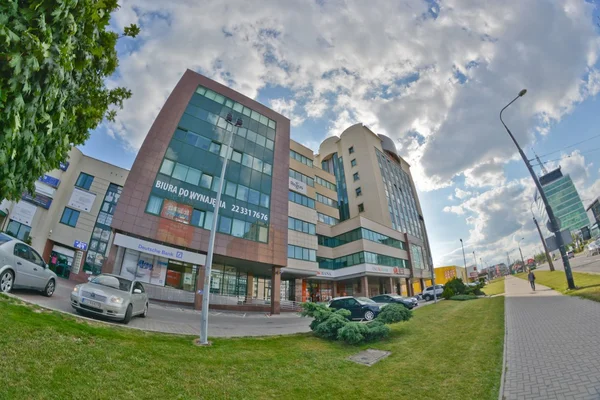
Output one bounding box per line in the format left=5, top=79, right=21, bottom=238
left=0, top=148, right=129, bottom=282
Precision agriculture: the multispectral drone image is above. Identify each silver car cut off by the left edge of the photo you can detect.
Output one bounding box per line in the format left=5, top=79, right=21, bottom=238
left=0, top=233, right=56, bottom=297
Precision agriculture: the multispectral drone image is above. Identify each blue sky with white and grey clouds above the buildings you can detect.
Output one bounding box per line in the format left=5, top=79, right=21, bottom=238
left=82, top=0, right=600, bottom=267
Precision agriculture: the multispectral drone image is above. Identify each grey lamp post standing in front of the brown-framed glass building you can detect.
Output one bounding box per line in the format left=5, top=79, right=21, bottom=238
left=200, top=113, right=242, bottom=345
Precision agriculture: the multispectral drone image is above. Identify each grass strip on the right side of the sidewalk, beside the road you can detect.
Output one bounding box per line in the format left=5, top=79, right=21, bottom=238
left=512, top=271, right=600, bottom=301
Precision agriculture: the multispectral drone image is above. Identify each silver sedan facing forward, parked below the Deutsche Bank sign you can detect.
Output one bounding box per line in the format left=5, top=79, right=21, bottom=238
left=71, top=274, right=148, bottom=324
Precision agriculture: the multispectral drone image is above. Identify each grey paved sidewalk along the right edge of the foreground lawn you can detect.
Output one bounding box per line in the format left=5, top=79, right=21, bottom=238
left=501, top=276, right=600, bottom=400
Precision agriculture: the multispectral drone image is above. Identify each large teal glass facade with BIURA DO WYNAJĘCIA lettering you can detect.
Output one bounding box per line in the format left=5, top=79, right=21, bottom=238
left=146, top=83, right=276, bottom=243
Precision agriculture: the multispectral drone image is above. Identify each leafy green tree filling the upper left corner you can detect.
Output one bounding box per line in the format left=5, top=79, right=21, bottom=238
left=0, top=0, right=139, bottom=199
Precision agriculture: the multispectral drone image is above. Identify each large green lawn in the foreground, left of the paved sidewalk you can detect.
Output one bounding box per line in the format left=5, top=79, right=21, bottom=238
left=0, top=295, right=504, bottom=400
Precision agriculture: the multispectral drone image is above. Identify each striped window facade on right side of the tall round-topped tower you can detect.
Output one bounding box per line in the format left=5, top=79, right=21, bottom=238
left=375, top=149, right=424, bottom=239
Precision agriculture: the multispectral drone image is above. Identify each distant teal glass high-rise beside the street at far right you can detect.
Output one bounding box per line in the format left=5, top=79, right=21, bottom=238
left=536, top=167, right=590, bottom=231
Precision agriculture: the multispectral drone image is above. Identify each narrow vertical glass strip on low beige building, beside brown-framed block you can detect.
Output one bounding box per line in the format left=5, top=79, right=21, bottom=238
left=83, top=183, right=123, bottom=275
